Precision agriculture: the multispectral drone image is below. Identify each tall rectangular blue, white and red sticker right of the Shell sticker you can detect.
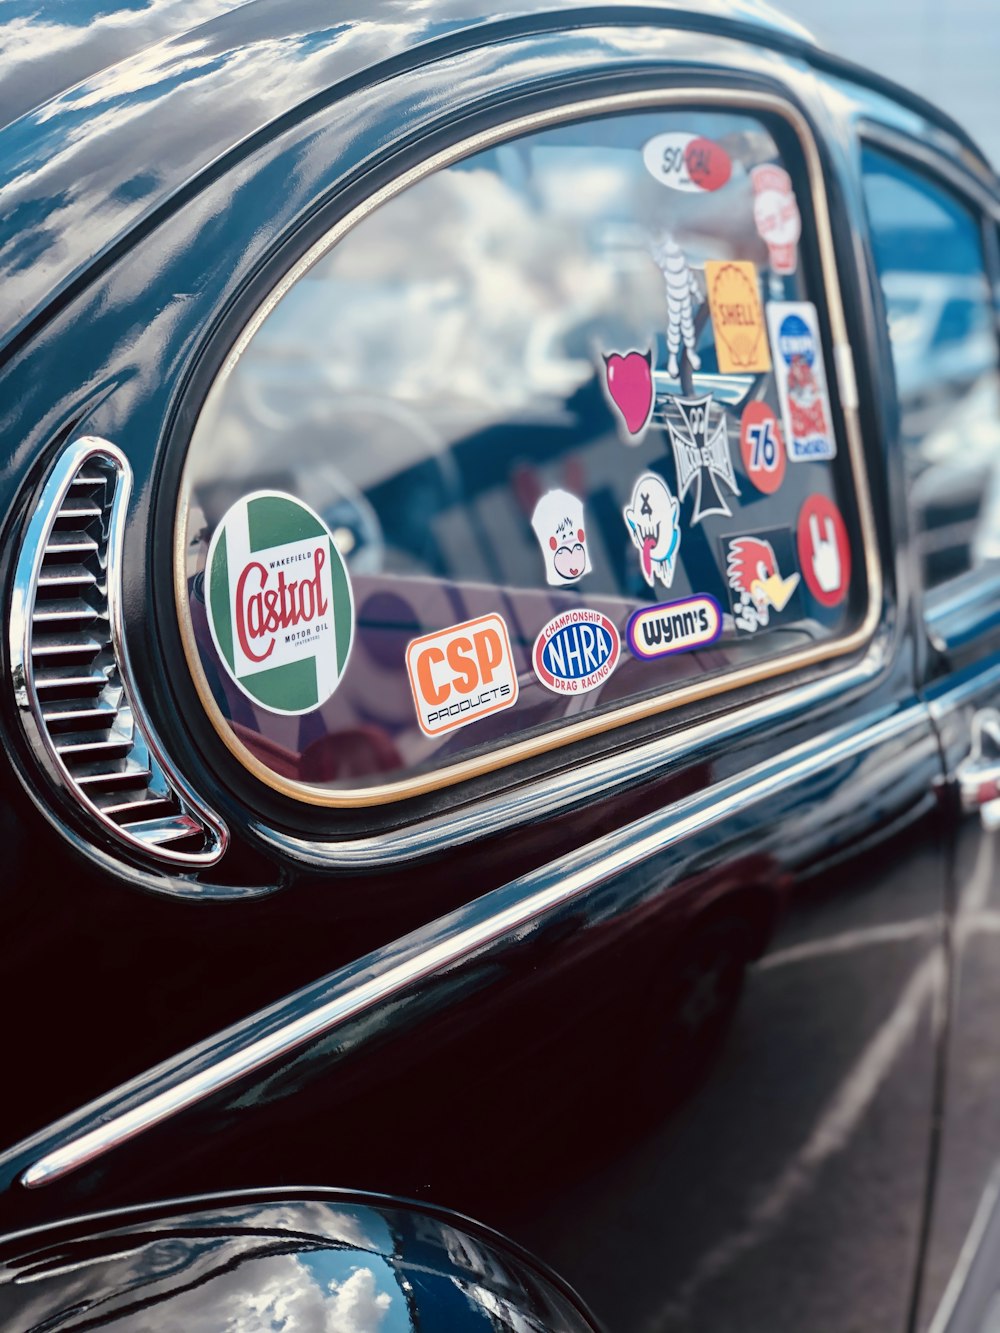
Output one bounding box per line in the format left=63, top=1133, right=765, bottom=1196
left=768, top=301, right=837, bottom=463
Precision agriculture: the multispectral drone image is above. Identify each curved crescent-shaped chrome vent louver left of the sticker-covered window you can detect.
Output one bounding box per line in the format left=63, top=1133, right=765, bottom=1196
left=11, top=439, right=228, bottom=866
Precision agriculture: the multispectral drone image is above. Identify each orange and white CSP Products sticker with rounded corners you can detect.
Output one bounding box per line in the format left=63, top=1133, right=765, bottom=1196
left=407, top=613, right=517, bottom=736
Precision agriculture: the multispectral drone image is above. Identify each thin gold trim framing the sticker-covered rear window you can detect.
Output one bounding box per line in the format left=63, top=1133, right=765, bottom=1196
left=173, top=87, right=883, bottom=809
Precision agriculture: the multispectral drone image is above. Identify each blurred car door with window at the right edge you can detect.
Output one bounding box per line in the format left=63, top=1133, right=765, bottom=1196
left=864, top=131, right=1000, bottom=1329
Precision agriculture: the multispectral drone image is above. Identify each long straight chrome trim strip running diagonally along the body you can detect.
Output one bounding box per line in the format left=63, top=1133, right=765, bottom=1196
left=20, top=702, right=929, bottom=1189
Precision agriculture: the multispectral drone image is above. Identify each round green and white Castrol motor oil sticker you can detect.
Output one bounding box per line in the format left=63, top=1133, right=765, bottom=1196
left=205, top=491, right=355, bottom=714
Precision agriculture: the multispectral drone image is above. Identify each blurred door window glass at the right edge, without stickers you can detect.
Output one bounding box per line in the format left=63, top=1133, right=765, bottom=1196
left=863, top=147, right=1000, bottom=588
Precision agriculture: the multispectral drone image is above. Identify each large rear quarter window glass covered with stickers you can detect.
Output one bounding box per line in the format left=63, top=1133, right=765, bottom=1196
left=181, top=109, right=869, bottom=792
